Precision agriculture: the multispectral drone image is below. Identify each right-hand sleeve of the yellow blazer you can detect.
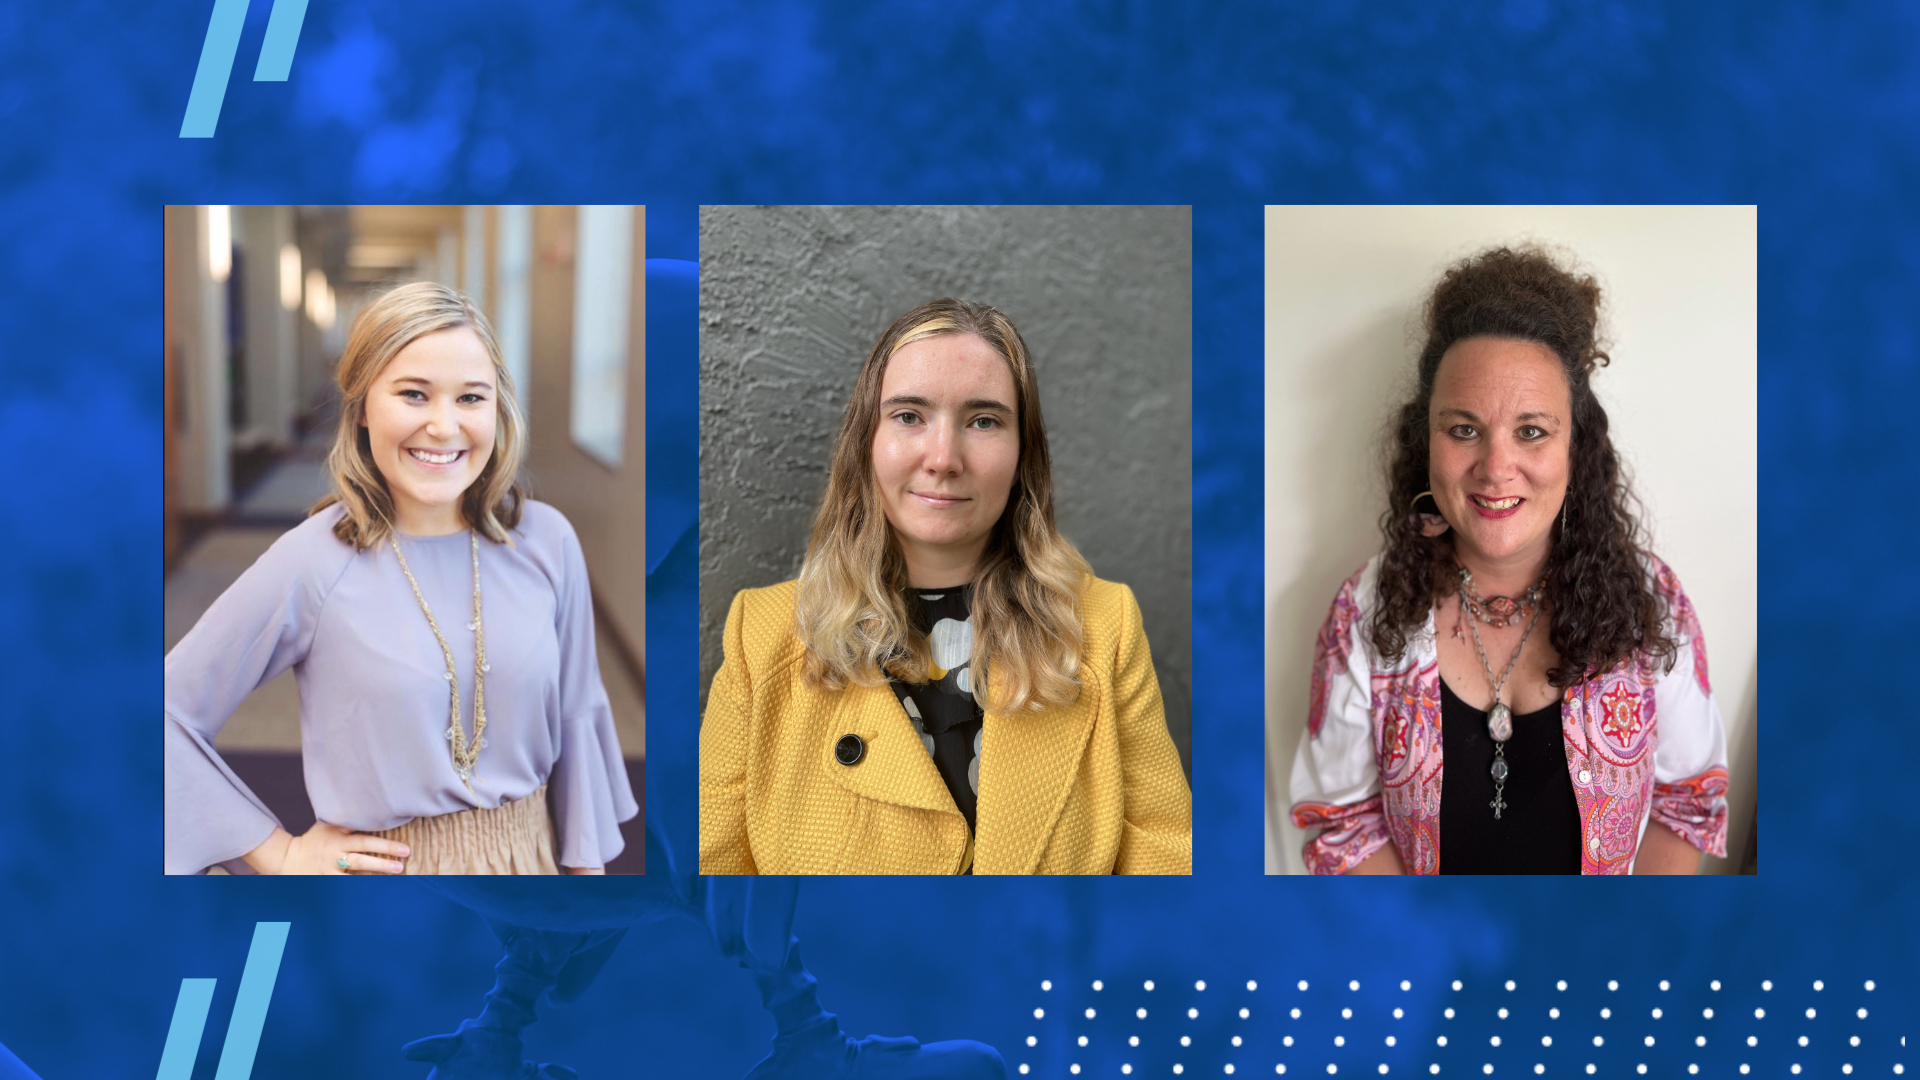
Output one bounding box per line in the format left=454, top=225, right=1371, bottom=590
left=1114, top=586, right=1194, bottom=874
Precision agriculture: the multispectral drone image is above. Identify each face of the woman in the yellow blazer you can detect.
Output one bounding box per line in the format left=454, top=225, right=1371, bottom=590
left=874, top=334, right=1020, bottom=588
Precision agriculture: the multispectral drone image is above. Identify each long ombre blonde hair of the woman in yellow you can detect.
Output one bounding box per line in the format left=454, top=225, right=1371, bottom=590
left=795, top=300, right=1092, bottom=713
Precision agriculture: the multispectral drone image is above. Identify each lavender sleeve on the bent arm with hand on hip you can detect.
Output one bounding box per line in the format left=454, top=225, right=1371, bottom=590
left=163, top=523, right=351, bottom=874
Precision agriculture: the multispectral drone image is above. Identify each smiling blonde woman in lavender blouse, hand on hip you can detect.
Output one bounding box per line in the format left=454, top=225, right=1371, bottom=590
left=165, top=282, right=637, bottom=874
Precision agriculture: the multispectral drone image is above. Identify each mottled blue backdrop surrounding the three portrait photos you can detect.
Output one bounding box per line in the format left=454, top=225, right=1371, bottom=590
left=0, top=0, right=1920, bottom=1080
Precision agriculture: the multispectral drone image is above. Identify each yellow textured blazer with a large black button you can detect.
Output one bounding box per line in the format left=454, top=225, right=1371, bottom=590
left=701, top=578, right=1192, bottom=874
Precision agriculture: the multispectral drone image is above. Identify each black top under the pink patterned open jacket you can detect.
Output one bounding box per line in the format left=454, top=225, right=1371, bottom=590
left=1440, top=678, right=1580, bottom=874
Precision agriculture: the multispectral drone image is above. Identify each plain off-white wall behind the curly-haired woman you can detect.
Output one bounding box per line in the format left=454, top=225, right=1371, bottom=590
left=1263, top=206, right=1759, bottom=872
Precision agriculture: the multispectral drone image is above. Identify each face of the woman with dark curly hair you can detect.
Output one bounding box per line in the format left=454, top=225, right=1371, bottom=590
left=1427, top=338, right=1572, bottom=575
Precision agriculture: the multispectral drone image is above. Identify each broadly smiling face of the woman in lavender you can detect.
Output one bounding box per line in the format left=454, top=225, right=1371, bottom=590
left=361, top=327, right=499, bottom=536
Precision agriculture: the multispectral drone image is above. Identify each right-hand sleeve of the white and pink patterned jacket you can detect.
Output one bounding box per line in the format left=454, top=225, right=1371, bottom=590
left=1649, top=565, right=1726, bottom=857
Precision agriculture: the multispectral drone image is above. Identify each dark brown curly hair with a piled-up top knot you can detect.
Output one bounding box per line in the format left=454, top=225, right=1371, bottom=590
left=1369, top=248, right=1676, bottom=688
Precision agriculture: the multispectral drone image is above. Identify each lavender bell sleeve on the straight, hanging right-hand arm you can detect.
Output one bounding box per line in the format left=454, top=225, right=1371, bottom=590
left=547, top=527, right=639, bottom=869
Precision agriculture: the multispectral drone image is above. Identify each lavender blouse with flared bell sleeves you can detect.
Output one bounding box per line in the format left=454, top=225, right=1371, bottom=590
left=165, top=502, right=639, bottom=874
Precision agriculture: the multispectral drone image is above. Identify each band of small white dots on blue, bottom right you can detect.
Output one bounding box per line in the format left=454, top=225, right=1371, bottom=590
left=1020, top=978, right=1907, bottom=1076
